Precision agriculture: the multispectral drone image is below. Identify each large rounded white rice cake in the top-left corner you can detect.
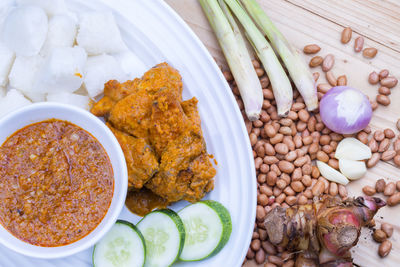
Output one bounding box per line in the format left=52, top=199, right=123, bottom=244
left=2, top=6, right=48, bottom=56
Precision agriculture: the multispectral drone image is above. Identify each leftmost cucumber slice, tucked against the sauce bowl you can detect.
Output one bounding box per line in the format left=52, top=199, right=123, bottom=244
left=93, top=220, right=146, bottom=267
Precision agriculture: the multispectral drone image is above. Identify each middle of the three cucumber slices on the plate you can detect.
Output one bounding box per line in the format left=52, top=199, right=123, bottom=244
left=137, top=209, right=185, bottom=267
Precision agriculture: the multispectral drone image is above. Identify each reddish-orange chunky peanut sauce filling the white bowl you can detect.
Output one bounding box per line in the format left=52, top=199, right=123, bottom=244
left=0, top=120, right=114, bottom=247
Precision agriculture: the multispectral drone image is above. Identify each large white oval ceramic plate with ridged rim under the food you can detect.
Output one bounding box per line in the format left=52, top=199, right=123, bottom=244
left=0, top=0, right=257, bottom=267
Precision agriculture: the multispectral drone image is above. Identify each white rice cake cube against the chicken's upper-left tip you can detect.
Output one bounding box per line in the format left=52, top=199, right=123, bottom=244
left=84, top=55, right=126, bottom=98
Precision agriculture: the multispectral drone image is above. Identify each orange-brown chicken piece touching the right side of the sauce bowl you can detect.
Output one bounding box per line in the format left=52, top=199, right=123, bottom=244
left=107, top=123, right=158, bottom=189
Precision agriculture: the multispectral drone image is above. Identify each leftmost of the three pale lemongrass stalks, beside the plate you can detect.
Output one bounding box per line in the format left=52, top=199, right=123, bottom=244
left=199, top=0, right=263, bottom=121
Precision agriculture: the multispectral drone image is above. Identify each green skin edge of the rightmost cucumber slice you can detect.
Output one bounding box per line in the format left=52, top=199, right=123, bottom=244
left=179, top=200, right=232, bottom=262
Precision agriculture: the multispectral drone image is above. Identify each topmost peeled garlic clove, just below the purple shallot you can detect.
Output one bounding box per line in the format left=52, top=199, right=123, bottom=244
left=335, top=137, right=372, bottom=160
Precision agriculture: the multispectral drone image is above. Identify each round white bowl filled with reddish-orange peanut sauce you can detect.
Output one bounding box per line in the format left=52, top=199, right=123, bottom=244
left=0, top=103, right=128, bottom=258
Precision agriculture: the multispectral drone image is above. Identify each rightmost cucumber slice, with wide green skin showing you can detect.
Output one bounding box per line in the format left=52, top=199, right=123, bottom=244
left=178, top=200, right=232, bottom=261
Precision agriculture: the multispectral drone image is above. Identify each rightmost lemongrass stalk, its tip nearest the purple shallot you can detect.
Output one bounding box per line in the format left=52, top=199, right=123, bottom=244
left=242, top=0, right=318, bottom=111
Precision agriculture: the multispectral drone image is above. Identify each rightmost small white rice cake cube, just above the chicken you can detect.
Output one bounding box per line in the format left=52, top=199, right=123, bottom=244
left=113, top=51, right=148, bottom=80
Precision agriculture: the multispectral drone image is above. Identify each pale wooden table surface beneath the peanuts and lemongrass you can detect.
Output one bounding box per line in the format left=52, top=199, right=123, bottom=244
left=166, top=0, right=400, bottom=267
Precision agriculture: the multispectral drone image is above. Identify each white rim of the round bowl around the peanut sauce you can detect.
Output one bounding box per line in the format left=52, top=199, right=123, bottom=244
left=0, top=102, right=128, bottom=259
